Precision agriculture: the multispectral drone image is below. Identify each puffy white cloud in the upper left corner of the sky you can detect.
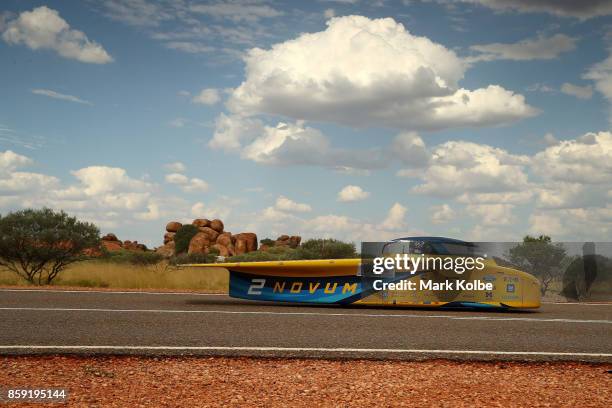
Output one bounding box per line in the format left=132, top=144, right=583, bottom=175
left=2, top=6, right=113, bottom=64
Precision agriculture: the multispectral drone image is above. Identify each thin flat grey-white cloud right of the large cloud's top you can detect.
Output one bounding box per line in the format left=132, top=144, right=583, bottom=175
left=468, top=34, right=576, bottom=62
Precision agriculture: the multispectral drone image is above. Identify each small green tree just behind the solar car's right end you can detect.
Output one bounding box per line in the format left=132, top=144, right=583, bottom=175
left=508, top=235, right=566, bottom=296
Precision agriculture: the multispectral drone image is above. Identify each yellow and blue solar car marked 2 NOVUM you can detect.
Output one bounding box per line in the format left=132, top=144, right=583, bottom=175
left=189, top=237, right=541, bottom=309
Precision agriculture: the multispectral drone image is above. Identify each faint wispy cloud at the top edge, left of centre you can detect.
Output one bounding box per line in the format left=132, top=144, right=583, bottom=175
left=191, top=1, right=283, bottom=22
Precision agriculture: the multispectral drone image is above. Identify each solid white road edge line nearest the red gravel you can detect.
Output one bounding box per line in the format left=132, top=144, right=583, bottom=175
left=0, top=345, right=612, bottom=357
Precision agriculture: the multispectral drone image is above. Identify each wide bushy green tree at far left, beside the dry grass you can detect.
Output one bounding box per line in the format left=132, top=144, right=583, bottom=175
left=0, top=208, right=100, bottom=285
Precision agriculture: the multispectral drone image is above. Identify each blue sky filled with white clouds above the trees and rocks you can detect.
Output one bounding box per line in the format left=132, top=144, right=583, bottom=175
left=0, top=0, right=612, bottom=246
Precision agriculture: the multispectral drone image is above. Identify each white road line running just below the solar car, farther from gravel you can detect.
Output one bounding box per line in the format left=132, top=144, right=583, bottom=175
left=0, top=307, right=612, bottom=324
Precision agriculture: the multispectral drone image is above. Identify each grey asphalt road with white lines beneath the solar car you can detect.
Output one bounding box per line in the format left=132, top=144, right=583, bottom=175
left=0, top=289, right=612, bottom=362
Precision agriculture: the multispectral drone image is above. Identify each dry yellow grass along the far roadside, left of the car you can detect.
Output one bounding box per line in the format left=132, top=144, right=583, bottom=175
left=0, top=261, right=228, bottom=292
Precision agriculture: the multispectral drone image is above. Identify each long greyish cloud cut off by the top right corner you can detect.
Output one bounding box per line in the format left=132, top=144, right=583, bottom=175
left=462, top=0, right=612, bottom=20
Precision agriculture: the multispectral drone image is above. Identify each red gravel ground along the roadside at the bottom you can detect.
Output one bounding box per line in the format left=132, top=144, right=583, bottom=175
left=0, top=356, right=612, bottom=407
